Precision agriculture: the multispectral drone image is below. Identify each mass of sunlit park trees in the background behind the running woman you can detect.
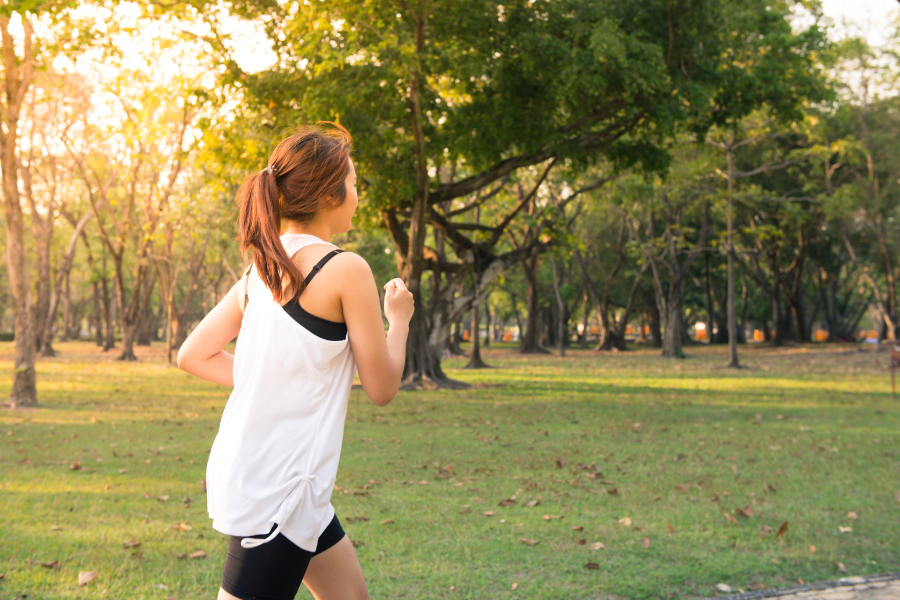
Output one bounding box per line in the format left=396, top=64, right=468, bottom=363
left=0, top=0, right=900, bottom=404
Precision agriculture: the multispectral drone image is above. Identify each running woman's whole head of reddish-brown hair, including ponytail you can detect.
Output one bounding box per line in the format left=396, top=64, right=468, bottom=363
left=237, top=122, right=351, bottom=302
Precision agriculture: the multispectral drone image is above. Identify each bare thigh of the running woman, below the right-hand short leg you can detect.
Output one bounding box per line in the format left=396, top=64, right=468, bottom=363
left=303, top=536, right=369, bottom=600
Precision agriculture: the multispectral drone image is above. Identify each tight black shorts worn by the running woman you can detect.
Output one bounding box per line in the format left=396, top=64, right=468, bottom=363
left=222, top=515, right=344, bottom=600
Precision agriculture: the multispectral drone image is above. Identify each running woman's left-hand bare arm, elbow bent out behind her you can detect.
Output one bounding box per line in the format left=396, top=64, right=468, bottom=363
left=178, top=280, right=243, bottom=387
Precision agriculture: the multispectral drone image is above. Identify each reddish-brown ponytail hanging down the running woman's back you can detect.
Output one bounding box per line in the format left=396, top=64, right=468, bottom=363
left=237, top=169, right=304, bottom=302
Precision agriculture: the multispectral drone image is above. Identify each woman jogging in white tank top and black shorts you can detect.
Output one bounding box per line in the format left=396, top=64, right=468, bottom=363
left=178, top=125, right=413, bottom=600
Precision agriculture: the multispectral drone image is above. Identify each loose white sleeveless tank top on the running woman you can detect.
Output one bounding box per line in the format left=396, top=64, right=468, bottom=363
left=206, top=234, right=356, bottom=552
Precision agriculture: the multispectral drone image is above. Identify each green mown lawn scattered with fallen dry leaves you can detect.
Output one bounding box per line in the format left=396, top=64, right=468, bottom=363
left=0, top=343, right=900, bottom=600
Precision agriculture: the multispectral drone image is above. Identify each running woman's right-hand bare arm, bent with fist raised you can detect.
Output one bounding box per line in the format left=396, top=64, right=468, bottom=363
left=341, top=252, right=415, bottom=406
